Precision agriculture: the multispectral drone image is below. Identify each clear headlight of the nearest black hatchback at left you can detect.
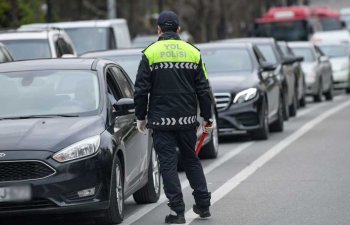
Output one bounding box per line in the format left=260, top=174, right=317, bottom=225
left=53, top=135, right=100, bottom=162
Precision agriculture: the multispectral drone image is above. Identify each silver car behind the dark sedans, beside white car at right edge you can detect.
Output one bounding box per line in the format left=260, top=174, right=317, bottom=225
left=288, top=42, right=333, bottom=102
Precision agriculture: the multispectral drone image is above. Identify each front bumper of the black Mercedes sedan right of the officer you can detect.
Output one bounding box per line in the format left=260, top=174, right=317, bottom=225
left=218, top=98, right=261, bottom=135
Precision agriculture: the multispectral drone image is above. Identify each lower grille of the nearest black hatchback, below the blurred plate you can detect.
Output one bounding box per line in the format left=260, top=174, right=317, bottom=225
left=0, top=199, right=57, bottom=211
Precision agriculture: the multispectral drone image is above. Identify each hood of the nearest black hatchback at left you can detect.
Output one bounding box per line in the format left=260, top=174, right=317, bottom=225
left=0, top=116, right=105, bottom=152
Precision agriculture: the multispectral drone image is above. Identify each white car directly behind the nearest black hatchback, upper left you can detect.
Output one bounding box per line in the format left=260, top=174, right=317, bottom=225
left=0, top=29, right=76, bottom=60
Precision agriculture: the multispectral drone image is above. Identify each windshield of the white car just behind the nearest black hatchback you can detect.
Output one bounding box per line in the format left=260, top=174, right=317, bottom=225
left=1, top=39, right=52, bottom=60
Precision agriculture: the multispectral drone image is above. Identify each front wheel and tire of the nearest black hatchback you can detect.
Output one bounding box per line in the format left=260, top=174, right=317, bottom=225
left=100, top=155, right=124, bottom=225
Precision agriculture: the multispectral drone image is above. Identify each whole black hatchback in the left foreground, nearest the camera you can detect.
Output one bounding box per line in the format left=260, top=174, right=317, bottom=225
left=0, top=59, right=161, bottom=224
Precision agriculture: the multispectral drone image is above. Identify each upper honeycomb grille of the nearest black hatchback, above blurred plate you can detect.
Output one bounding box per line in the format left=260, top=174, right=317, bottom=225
left=0, top=161, right=56, bottom=182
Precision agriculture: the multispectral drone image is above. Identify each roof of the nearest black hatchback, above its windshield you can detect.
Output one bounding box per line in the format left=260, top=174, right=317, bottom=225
left=0, top=58, right=98, bottom=72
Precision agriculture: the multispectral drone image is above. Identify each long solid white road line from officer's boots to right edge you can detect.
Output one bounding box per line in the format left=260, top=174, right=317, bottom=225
left=185, top=100, right=350, bottom=224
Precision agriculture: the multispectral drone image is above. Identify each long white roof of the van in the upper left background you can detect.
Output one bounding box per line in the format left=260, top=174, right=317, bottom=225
left=21, top=18, right=126, bottom=28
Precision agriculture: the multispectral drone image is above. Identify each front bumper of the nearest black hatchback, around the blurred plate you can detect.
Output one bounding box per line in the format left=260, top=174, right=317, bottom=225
left=0, top=151, right=112, bottom=215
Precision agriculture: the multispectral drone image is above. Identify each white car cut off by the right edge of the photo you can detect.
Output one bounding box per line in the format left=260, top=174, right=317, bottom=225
left=318, top=42, right=350, bottom=93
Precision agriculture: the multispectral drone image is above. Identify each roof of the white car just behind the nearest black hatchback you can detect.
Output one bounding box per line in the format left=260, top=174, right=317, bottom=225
left=0, top=30, right=53, bottom=40
